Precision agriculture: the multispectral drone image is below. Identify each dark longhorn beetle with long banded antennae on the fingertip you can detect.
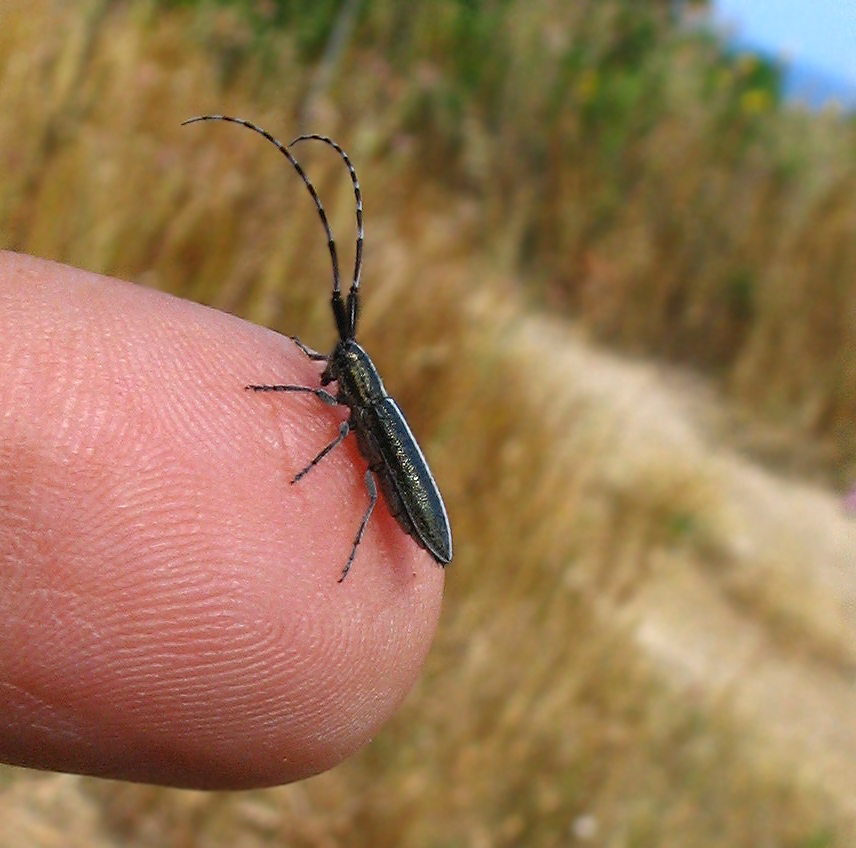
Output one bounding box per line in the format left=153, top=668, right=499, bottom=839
left=183, top=115, right=452, bottom=583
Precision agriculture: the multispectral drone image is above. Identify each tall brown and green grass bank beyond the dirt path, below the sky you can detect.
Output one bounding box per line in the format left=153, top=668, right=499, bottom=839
left=353, top=0, right=856, bottom=476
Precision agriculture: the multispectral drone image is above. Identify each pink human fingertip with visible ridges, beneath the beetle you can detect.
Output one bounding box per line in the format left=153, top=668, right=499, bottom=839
left=0, top=252, right=444, bottom=789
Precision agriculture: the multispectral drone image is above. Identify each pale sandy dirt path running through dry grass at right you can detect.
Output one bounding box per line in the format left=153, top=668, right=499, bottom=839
left=522, top=321, right=856, bottom=823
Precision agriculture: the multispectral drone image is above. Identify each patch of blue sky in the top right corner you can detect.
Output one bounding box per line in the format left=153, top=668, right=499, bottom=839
left=713, top=0, right=856, bottom=85
